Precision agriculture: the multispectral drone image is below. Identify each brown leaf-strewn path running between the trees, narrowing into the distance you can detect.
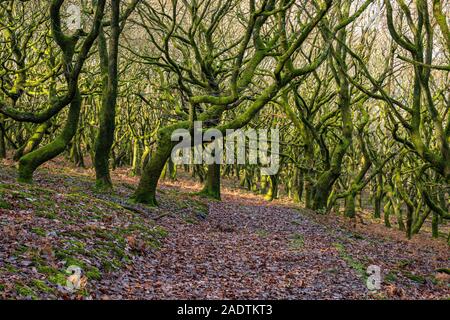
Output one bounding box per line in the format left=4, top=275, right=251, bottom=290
left=98, top=192, right=367, bottom=299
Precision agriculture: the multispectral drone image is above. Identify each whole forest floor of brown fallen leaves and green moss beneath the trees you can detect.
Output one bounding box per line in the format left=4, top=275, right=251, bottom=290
left=0, top=161, right=450, bottom=299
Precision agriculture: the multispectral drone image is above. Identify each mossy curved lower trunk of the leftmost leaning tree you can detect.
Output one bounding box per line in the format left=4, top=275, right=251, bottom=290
left=18, top=90, right=81, bottom=183
